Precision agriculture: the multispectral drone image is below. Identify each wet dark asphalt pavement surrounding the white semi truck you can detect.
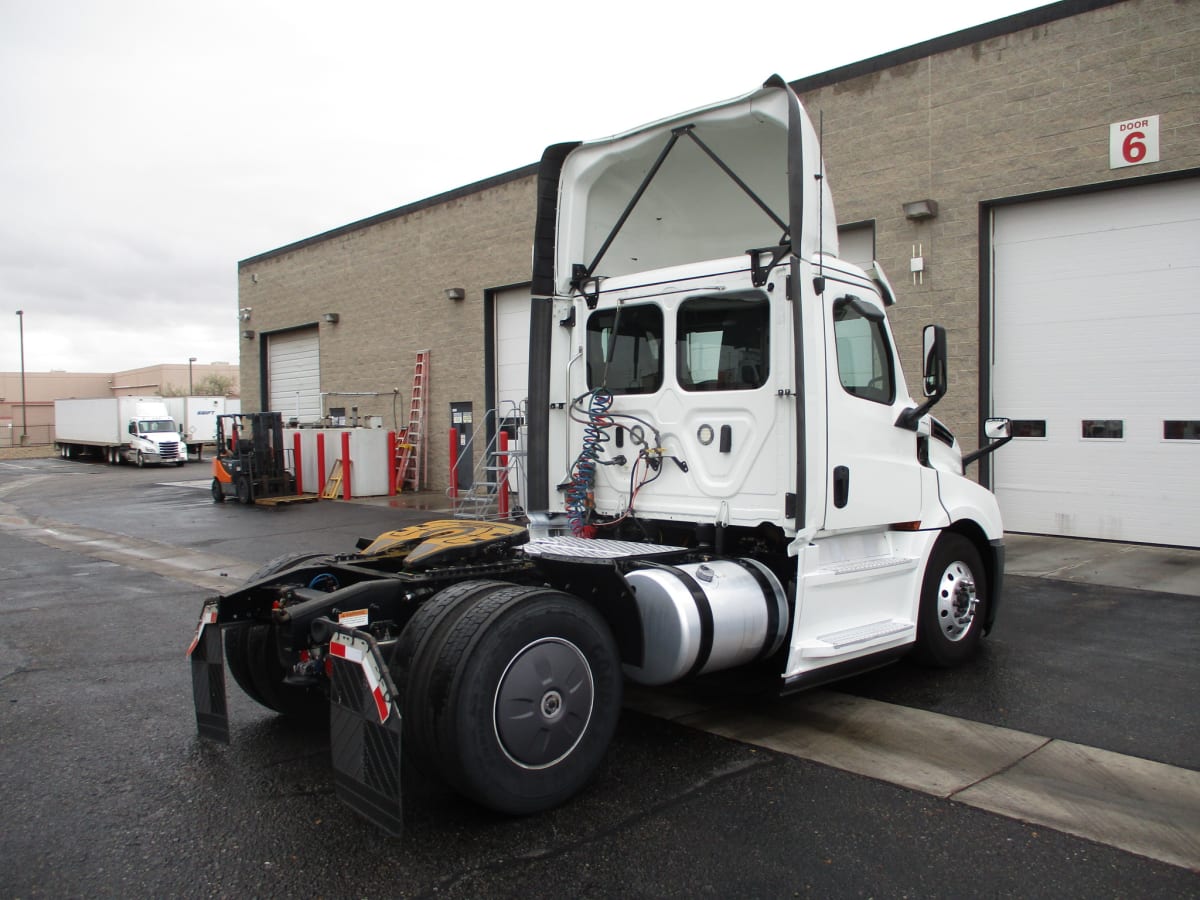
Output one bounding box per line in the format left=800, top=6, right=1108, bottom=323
left=0, top=460, right=1200, bottom=896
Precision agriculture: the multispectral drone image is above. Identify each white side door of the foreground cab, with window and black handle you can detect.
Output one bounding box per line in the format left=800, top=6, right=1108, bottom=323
left=823, top=287, right=922, bottom=530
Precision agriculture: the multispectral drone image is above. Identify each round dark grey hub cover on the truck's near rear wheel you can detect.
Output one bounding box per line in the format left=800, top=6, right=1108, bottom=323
left=492, top=637, right=595, bottom=769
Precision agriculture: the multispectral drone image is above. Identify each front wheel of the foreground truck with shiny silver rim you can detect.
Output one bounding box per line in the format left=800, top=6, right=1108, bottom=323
left=913, top=534, right=989, bottom=667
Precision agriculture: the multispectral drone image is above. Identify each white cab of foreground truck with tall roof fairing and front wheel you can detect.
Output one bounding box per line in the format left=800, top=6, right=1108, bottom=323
left=529, top=78, right=1003, bottom=688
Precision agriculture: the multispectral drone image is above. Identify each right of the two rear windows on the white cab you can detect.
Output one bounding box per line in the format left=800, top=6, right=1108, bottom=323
left=676, top=294, right=770, bottom=391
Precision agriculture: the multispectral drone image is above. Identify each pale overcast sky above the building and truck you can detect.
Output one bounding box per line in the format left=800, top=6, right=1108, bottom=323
left=0, top=0, right=1040, bottom=372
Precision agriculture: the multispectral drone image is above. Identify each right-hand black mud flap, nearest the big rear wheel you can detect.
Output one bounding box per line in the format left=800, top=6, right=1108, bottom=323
left=329, top=623, right=403, bottom=836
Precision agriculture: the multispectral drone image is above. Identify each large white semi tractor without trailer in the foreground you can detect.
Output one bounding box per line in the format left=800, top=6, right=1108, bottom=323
left=190, top=77, right=1007, bottom=832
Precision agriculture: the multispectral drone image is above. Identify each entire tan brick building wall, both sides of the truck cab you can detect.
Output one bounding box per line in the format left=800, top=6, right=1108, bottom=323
left=239, top=0, right=1200, bottom=488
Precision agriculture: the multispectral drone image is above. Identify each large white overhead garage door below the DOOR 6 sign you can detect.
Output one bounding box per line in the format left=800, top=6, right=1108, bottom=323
left=992, top=179, right=1200, bottom=546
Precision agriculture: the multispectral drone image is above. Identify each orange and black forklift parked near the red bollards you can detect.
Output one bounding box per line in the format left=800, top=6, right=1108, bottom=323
left=212, top=413, right=296, bottom=504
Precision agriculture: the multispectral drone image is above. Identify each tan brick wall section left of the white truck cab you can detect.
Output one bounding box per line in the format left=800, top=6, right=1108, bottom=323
left=238, top=168, right=536, bottom=490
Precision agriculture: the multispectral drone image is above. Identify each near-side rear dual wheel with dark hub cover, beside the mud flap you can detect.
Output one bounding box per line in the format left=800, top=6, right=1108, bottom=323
left=394, top=582, right=622, bottom=815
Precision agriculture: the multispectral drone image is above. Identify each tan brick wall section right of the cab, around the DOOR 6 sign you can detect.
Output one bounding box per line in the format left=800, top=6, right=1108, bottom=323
left=796, top=0, right=1200, bottom=448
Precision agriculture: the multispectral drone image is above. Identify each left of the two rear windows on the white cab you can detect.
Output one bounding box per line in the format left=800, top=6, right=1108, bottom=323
left=587, top=306, right=662, bottom=394
